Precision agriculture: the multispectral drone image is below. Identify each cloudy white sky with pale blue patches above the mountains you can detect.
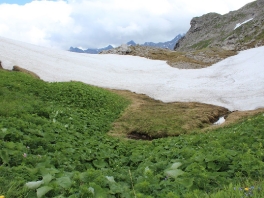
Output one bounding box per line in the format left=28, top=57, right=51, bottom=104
left=0, top=0, right=252, bottom=50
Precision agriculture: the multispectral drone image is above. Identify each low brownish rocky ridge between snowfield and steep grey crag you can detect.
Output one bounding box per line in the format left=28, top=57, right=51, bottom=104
left=100, top=44, right=236, bottom=69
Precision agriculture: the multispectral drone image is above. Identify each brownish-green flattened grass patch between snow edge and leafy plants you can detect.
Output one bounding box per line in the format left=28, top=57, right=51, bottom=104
left=109, top=90, right=230, bottom=139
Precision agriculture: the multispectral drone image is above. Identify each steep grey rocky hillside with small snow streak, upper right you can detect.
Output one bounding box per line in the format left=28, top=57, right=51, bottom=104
left=174, top=0, right=264, bottom=51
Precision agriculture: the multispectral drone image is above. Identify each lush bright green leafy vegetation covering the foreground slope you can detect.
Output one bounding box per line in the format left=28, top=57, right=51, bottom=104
left=0, top=70, right=264, bottom=197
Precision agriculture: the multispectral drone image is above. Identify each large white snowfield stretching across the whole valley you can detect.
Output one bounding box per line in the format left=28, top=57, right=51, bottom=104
left=0, top=37, right=264, bottom=111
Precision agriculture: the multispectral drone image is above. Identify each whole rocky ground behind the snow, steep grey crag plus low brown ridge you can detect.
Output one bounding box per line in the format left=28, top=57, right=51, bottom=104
left=101, top=0, right=264, bottom=69
